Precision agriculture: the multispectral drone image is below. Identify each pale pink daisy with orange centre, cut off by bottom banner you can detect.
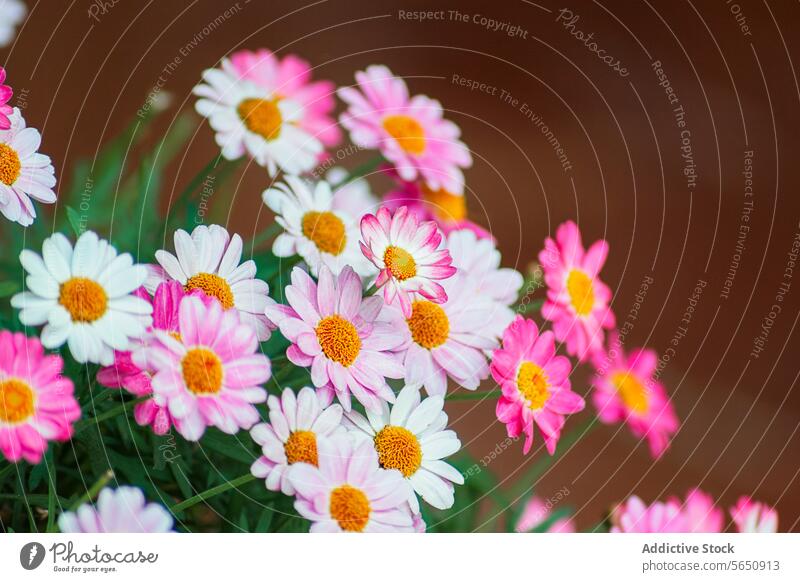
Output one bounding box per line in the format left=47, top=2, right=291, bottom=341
left=288, top=435, right=414, bottom=533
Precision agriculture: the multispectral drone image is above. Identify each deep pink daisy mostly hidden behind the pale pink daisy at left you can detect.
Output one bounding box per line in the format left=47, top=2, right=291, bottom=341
left=97, top=281, right=198, bottom=435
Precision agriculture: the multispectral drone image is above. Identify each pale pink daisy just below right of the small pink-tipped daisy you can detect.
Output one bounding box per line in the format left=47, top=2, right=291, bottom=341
left=392, top=274, right=498, bottom=396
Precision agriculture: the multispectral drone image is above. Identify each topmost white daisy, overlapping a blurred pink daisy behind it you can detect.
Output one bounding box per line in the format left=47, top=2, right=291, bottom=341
left=193, top=63, right=323, bottom=176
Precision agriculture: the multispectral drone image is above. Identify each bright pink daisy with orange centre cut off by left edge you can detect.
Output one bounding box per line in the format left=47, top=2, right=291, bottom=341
left=0, top=331, right=81, bottom=463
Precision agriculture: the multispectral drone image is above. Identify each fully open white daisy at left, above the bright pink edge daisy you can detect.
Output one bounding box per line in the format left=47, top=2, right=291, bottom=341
left=11, top=231, right=152, bottom=366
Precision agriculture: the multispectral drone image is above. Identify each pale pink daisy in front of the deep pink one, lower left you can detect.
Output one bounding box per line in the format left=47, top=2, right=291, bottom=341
left=133, top=296, right=270, bottom=441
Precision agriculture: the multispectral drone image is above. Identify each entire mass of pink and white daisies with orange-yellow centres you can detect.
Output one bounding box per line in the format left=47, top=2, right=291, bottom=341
left=0, top=46, right=777, bottom=532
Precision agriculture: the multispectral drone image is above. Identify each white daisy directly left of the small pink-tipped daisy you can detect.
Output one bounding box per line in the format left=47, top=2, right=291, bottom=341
left=261, top=176, right=377, bottom=277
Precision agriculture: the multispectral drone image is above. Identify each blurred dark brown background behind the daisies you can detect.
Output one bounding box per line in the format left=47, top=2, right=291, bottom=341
left=0, top=0, right=800, bottom=530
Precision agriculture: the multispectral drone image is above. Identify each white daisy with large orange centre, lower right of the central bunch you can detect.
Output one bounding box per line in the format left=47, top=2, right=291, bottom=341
left=344, top=385, right=464, bottom=514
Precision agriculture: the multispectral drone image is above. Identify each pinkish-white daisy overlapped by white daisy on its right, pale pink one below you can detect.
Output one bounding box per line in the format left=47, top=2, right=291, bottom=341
left=250, top=387, right=345, bottom=495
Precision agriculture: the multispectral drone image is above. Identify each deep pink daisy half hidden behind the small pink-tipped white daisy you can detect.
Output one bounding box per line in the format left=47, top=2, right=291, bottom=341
left=383, top=175, right=492, bottom=239
